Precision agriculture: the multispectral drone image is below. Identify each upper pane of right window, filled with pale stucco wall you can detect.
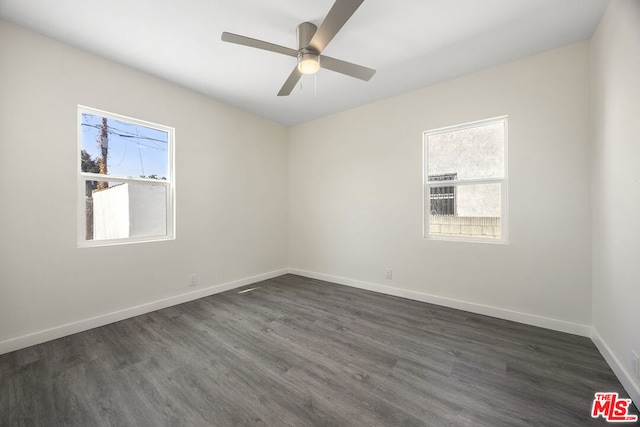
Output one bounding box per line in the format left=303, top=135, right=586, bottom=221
left=427, top=122, right=504, bottom=182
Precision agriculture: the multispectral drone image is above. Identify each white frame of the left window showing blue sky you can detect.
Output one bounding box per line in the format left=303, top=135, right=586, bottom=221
left=76, top=105, right=176, bottom=248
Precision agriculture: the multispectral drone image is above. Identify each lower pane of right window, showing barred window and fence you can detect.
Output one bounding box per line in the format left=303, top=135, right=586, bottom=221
left=429, top=183, right=502, bottom=239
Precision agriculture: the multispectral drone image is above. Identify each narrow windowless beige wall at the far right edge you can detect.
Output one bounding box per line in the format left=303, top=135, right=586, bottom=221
left=591, top=0, right=640, bottom=406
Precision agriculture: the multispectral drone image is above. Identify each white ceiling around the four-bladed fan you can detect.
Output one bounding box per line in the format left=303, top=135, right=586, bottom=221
left=0, top=0, right=608, bottom=125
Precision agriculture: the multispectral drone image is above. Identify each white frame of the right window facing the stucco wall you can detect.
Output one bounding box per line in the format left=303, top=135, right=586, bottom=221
left=422, top=116, right=509, bottom=244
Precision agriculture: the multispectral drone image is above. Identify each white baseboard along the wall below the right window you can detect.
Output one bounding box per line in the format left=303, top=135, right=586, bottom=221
left=289, top=268, right=591, bottom=337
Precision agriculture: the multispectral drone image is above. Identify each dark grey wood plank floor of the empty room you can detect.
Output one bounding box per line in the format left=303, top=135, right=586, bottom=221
left=0, top=275, right=638, bottom=427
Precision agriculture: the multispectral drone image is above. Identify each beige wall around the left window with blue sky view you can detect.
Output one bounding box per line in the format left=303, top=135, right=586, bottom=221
left=0, top=21, right=287, bottom=350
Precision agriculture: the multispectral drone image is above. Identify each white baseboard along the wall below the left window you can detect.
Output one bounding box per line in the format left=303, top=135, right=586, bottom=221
left=0, top=269, right=288, bottom=354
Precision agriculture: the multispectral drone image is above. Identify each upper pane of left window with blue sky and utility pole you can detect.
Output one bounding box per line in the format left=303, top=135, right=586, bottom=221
left=80, top=113, right=169, bottom=179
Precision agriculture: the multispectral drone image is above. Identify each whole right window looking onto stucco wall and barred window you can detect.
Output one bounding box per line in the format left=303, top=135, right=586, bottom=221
left=423, top=117, right=507, bottom=243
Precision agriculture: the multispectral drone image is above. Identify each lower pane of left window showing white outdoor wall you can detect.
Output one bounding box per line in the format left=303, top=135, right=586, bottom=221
left=85, top=181, right=167, bottom=240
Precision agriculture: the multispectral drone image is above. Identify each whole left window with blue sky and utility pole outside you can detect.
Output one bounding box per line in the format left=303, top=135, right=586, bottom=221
left=78, top=106, right=175, bottom=246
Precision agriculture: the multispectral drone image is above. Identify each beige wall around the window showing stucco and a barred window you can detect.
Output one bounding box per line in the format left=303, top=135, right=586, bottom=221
left=289, top=42, right=591, bottom=334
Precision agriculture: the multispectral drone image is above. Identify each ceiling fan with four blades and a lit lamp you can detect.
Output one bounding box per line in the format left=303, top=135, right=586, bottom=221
left=222, top=0, right=376, bottom=96
